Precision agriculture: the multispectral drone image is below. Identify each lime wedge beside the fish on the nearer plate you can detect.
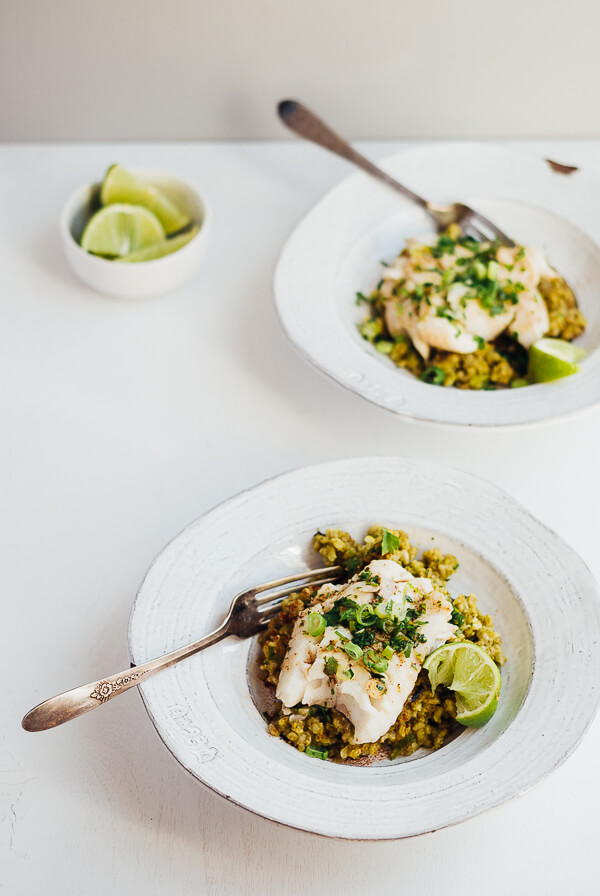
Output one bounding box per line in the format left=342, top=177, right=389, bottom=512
left=423, top=641, right=502, bottom=728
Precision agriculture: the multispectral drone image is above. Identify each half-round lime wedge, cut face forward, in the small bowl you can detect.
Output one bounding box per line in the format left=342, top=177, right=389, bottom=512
left=81, top=203, right=165, bottom=258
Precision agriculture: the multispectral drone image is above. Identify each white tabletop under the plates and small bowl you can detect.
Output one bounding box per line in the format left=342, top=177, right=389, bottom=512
left=0, top=141, right=600, bottom=896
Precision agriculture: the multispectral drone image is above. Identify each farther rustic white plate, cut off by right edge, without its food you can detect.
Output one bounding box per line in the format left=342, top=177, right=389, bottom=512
left=274, top=144, right=600, bottom=426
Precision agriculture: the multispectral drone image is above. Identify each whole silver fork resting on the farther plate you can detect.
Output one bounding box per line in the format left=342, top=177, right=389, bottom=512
left=277, top=100, right=515, bottom=246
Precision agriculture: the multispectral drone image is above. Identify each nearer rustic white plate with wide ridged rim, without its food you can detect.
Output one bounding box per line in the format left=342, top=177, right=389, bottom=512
left=129, top=457, right=600, bottom=840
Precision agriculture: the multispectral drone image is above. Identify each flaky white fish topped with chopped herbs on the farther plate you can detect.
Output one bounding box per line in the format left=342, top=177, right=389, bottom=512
left=379, top=235, right=558, bottom=360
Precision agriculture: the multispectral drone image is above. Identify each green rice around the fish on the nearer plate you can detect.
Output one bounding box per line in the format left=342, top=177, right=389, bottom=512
left=260, top=526, right=505, bottom=761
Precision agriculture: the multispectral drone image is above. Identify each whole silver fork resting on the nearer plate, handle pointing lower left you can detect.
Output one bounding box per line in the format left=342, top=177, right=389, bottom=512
left=22, top=566, right=343, bottom=731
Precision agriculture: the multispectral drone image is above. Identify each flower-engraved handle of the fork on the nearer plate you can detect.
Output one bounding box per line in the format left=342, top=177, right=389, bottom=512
left=21, top=621, right=229, bottom=731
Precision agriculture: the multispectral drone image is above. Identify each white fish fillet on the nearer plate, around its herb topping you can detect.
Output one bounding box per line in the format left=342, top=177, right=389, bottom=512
left=276, top=560, right=456, bottom=744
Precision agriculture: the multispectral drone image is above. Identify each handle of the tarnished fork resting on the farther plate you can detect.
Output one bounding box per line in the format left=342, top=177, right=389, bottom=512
left=277, top=100, right=428, bottom=209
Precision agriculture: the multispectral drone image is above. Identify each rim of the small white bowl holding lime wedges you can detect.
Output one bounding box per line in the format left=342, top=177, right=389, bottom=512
left=58, top=165, right=212, bottom=270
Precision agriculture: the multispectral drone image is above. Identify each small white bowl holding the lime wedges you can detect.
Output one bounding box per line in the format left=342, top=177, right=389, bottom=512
left=60, top=168, right=212, bottom=299
